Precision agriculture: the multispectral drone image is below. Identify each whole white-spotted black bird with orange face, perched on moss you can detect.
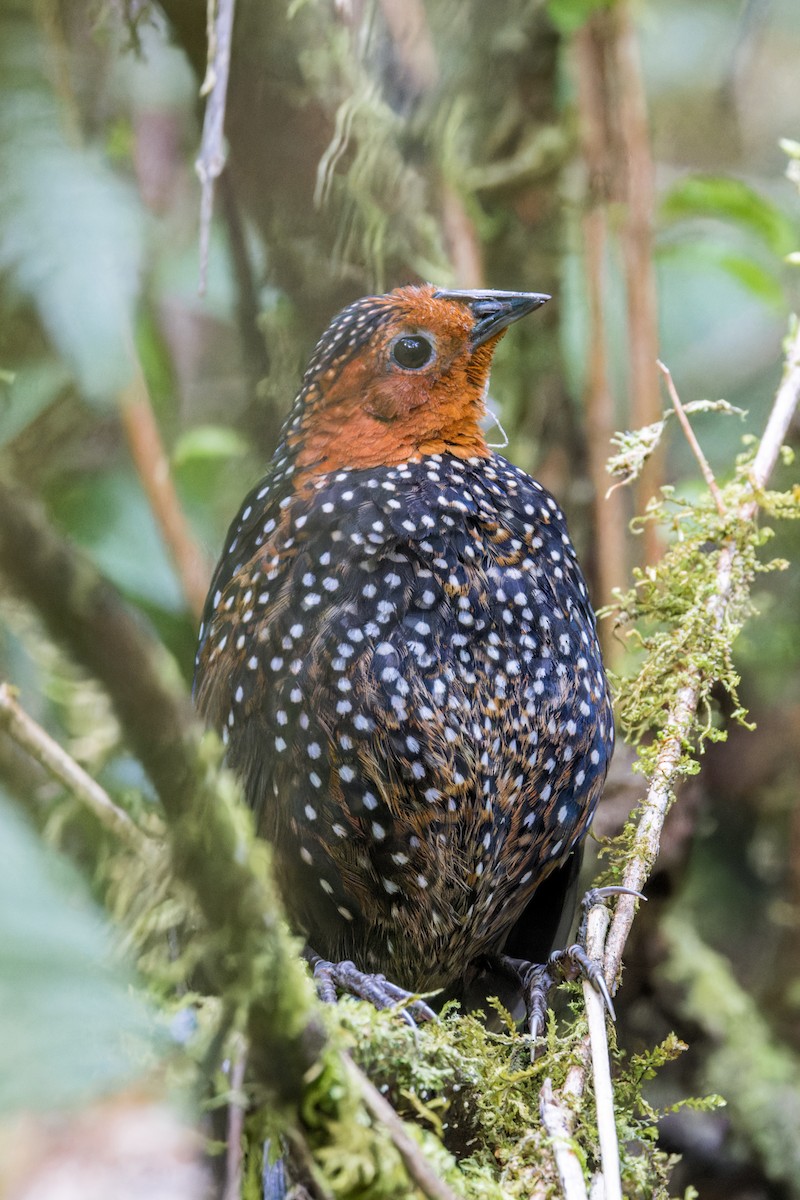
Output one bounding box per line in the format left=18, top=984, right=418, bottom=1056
left=194, top=283, right=614, bottom=1027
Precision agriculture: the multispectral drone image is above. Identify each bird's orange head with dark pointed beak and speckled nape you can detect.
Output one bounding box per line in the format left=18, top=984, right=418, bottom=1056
left=288, top=284, right=549, bottom=481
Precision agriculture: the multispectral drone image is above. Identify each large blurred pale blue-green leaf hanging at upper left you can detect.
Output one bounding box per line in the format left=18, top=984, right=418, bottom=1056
left=0, top=5, right=143, bottom=403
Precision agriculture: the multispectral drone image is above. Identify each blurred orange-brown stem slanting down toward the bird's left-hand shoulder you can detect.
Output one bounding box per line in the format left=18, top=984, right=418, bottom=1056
left=120, top=364, right=211, bottom=620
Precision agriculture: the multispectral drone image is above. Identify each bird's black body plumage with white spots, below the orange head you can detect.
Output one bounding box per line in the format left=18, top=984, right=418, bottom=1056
left=196, top=451, right=613, bottom=990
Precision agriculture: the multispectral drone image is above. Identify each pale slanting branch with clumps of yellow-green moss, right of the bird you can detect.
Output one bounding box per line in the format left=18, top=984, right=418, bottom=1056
left=546, top=323, right=800, bottom=1190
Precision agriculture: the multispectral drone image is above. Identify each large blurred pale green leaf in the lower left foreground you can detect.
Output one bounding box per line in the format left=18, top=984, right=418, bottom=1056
left=0, top=793, right=163, bottom=1114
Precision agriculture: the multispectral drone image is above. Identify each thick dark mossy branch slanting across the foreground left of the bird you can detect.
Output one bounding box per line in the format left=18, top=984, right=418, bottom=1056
left=0, top=482, right=325, bottom=1105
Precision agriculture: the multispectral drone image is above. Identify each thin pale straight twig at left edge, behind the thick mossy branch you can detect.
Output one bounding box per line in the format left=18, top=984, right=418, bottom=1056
left=0, top=683, right=149, bottom=850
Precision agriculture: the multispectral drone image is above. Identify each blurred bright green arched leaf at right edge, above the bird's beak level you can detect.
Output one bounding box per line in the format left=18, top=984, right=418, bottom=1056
left=661, top=175, right=798, bottom=258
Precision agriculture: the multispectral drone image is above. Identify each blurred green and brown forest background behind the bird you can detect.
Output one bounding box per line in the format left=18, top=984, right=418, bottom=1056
left=0, top=0, right=800, bottom=1198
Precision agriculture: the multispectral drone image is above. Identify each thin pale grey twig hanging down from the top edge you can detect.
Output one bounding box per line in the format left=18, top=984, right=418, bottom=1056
left=194, top=0, right=235, bottom=295
